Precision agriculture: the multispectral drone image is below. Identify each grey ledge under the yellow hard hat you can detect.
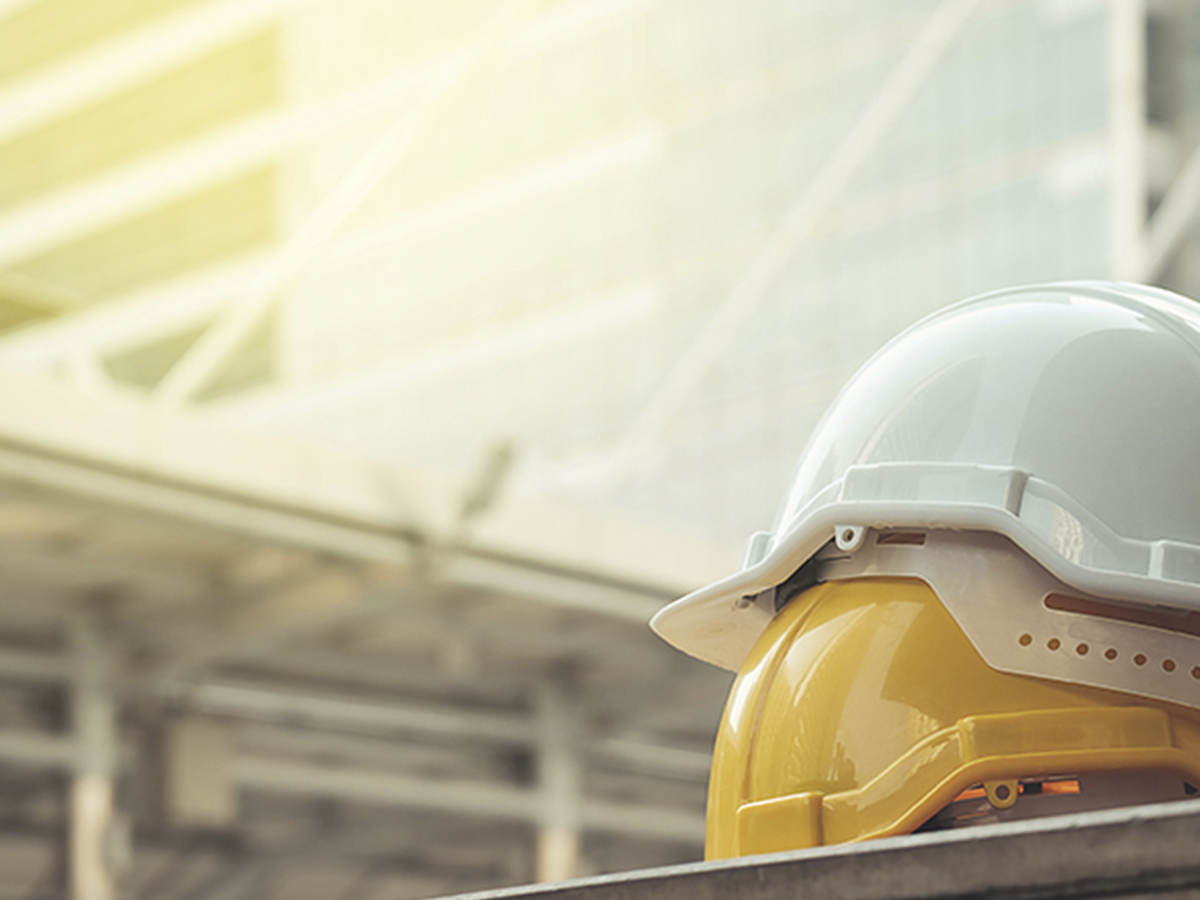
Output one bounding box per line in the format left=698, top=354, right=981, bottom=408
left=444, top=800, right=1200, bottom=900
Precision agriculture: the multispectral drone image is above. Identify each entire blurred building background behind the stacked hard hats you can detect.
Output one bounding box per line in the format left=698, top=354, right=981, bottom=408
left=0, top=0, right=1200, bottom=900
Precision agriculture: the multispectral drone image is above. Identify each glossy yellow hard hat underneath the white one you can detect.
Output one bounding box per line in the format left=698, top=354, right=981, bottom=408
left=706, top=578, right=1200, bottom=859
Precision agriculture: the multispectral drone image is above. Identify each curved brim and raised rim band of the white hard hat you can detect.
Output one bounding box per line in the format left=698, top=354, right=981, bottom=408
left=650, top=463, right=1200, bottom=672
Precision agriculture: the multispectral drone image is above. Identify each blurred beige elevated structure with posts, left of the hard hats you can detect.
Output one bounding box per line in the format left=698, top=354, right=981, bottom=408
left=0, top=367, right=725, bottom=898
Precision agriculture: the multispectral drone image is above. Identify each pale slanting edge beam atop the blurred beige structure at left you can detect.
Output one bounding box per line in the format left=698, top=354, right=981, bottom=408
left=0, top=367, right=728, bottom=623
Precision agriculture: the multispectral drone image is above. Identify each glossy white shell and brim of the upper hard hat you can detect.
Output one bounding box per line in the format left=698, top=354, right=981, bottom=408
left=652, top=282, right=1200, bottom=671
